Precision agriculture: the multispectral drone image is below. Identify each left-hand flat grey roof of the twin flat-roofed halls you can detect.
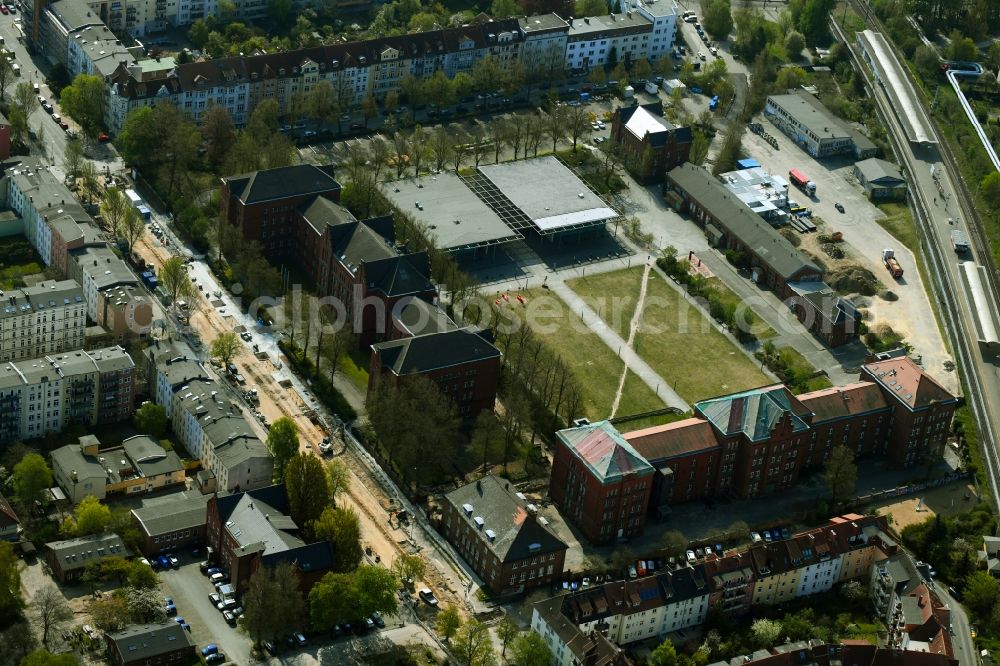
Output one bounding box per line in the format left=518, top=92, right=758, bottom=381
left=382, top=172, right=521, bottom=250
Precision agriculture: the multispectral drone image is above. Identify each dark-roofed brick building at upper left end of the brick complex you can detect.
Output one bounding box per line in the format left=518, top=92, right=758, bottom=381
left=221, top=164, right=341, bottom=258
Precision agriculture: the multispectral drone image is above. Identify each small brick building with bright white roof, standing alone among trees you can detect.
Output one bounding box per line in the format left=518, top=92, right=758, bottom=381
left=611, top=102, right=692, bottom=183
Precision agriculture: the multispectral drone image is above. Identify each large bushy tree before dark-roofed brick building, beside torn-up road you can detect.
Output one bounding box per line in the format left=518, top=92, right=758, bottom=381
left=368, top=376, right=459, bottom=482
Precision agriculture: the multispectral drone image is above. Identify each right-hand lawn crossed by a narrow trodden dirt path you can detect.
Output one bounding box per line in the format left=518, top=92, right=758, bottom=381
left=568, top=266, right=769, bottom=402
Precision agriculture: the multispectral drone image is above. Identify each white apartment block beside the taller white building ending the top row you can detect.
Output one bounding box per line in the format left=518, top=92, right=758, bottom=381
left=566, top=10, right=652, bottom=71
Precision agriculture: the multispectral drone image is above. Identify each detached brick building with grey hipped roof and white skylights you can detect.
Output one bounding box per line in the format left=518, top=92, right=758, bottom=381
left=441, top=475, right=567, bottom=595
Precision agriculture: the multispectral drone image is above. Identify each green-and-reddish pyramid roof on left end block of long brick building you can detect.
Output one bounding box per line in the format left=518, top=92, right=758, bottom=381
left=557, top=421, right=654, bottom=483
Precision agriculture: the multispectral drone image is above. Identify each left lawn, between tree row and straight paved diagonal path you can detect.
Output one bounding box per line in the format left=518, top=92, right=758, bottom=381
left=511, top=289, right=664, bottom=420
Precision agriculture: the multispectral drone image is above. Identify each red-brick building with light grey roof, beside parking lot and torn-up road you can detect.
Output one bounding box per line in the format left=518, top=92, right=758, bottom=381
left=205, top=485, right=333, bottom=594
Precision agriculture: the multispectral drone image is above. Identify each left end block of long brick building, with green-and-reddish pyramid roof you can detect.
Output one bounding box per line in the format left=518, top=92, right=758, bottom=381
left=549, top=421, right=655, bottom=543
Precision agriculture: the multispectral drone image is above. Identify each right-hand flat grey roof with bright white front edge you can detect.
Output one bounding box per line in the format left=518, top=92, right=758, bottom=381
left=479, top=157, right=618, bottom=232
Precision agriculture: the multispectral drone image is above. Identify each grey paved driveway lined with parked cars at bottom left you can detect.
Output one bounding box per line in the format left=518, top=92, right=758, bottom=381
left=160, top=551, right=251, bottom=664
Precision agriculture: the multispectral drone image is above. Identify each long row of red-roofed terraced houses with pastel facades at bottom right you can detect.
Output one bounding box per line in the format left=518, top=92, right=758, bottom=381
left=531, top=514, right=900, bottom=663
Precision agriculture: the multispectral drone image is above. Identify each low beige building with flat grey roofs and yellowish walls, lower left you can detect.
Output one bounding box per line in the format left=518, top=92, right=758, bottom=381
left=52, top=435, right=184, bottom=504
